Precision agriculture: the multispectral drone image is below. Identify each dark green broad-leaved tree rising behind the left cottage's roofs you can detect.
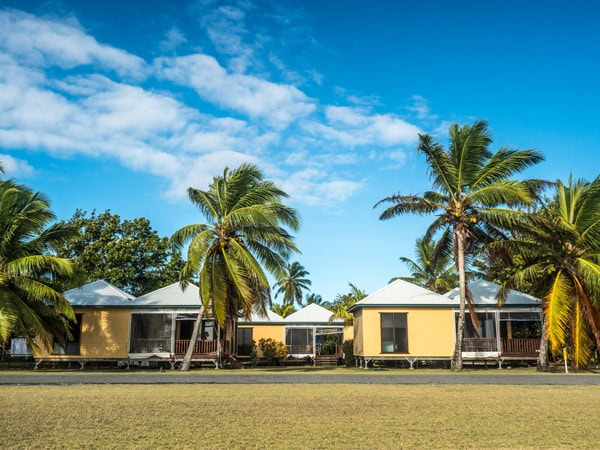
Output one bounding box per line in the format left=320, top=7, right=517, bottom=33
left=59, top=210, right=183, bottom=296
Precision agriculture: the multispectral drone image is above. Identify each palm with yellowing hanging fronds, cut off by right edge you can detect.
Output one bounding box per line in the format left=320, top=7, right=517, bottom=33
left=496, top=177, right=600, bottom=370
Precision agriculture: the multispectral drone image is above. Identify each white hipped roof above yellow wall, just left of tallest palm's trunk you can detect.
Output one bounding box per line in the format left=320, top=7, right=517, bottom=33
left=351, top=280, right=451, bottom=309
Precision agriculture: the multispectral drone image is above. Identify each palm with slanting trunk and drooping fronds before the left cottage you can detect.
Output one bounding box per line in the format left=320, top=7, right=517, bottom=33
left=171, top=164, right=299, bottom=370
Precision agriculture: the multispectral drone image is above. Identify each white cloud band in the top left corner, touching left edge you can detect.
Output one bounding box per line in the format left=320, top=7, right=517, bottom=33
left=0, top=10, right=146, bottom=77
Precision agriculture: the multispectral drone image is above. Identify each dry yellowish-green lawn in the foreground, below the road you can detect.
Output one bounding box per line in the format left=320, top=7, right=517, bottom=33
left=0, top=385, right=600, bottom=449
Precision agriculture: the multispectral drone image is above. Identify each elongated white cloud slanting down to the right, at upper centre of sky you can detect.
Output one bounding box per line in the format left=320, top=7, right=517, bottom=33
left=156, top=54, right=316, bottom=130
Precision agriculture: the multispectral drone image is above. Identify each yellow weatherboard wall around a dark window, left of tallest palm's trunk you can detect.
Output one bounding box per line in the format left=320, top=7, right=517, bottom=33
left=354, top=308, right=454, bottom=357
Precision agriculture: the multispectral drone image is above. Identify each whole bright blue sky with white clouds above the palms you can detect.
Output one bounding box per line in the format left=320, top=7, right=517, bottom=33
left=0, top=0, right=600, bottom=300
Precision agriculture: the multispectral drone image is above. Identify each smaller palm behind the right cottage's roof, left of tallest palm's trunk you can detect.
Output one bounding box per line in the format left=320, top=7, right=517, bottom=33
left=390, top=237, right=458, bottom=294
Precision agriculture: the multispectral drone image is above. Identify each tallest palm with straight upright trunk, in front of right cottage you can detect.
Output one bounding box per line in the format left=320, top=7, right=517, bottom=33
left=375, top=120, right=543, bottom=370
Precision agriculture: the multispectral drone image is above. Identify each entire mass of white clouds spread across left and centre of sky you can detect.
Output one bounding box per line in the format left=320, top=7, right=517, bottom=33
left=0, top=2, right=432, bottom=205
